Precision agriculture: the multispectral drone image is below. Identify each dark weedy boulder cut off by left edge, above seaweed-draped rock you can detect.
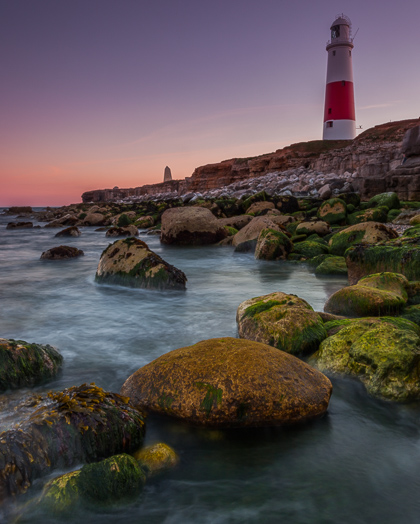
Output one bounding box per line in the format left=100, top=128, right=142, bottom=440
left=0, top=338, right=63, bottom=391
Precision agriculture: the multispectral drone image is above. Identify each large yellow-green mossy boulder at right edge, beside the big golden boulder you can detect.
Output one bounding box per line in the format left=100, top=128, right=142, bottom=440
left=311, top=319, right=420, bottom=402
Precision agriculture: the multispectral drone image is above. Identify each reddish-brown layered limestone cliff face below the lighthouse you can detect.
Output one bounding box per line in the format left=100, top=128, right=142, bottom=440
left=82, top=119, right=420, bottom=202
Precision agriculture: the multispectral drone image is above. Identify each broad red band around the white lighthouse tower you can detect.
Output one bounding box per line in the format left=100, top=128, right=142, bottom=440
left=324, top=80, right=356, bottom=122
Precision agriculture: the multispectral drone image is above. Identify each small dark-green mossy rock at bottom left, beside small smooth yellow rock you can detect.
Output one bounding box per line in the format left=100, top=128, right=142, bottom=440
left=77, top=453, right=146, bottom=506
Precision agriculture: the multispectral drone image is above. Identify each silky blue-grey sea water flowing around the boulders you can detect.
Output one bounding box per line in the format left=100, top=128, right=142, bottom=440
left=0, top=210, right=420, bottom=524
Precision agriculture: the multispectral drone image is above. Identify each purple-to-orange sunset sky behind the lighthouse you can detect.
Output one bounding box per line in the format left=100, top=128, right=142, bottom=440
left=0, top=0, right=420, bottom=206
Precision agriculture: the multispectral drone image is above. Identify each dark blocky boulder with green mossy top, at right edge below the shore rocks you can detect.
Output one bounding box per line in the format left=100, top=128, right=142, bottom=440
left=346, top=236, right=420, bottom=284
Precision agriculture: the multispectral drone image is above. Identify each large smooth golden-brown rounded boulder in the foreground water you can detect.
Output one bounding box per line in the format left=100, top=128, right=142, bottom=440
left=121, top=338, right=332, bottom=427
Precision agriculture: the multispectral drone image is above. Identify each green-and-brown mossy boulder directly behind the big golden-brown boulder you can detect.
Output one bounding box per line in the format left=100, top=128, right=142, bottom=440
left=236, top=292, right=326, bottom=355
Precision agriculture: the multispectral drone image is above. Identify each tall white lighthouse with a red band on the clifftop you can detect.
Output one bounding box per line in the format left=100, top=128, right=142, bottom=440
left=322, top=14, right=356, bottom=140
